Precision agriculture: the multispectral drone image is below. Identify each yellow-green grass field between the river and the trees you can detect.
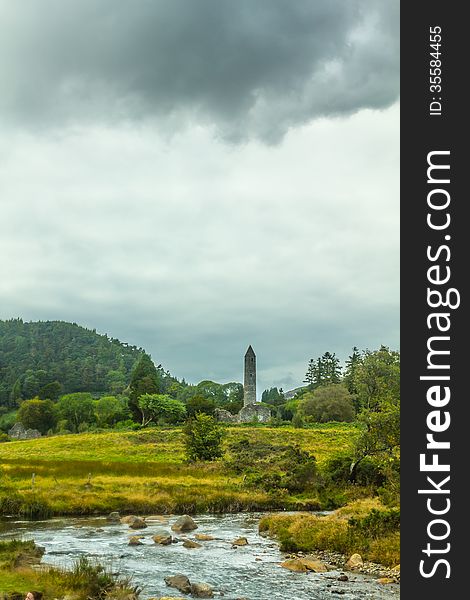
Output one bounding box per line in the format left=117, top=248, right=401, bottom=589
left=0, top=424, right=357, bottom=517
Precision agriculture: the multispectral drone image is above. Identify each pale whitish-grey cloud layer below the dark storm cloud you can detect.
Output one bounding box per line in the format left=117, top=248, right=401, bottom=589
left=0, top=107, right=398, bottom=391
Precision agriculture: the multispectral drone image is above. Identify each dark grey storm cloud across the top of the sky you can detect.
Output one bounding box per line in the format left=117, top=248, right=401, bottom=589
left=0, top=0, right=399, bottom=141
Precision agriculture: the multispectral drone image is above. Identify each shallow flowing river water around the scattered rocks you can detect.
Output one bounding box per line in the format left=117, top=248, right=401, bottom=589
left=0, top=513, right=399, bottom=600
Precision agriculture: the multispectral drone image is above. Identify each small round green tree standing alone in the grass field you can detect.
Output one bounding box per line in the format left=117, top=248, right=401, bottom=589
left=183, top=414, right=224, bottom=460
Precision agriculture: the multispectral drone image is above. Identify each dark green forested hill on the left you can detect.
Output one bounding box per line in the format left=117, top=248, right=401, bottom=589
left=0, top=319, right=144, bottom=406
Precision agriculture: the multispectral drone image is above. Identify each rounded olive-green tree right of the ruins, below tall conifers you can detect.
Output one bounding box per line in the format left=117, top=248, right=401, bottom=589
left=299, top=384, right=354, bottom=423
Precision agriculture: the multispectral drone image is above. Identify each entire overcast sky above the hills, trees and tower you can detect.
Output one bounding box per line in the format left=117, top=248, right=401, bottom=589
left=0, top=0, right=399, bottom=391
